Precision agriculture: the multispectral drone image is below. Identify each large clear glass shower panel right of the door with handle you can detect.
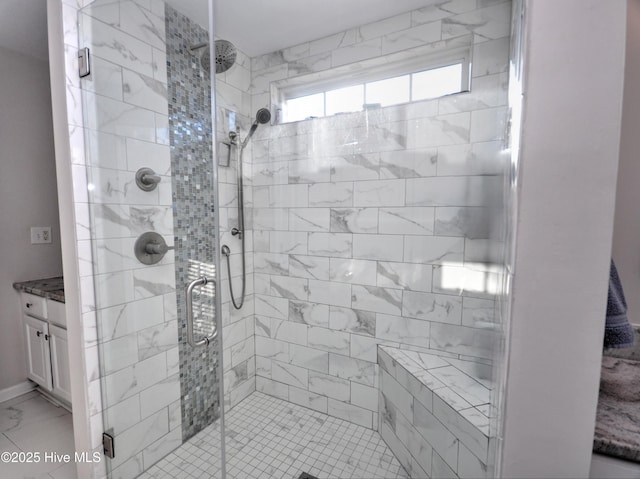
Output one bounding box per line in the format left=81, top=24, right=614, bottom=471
left=216, top=0, right=511, bottom=478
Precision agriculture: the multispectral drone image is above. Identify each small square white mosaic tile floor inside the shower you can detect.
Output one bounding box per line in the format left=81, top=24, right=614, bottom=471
left=140, top=392, right=408, bottom=479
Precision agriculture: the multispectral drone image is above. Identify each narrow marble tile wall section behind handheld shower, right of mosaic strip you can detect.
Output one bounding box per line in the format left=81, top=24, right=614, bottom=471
left=216, top=35, right=256, bottom=408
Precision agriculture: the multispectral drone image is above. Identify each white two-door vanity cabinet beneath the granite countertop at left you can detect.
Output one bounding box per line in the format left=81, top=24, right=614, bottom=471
left=20, top=292, right=71, bottom=404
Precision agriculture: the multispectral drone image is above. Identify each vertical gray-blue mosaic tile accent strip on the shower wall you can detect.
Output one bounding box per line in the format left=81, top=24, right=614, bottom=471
left=165, top=6, right=220, bottom=440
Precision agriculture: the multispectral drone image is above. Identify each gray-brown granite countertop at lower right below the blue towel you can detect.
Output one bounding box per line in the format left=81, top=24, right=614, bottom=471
left=593, top=356, right=640, bottom=462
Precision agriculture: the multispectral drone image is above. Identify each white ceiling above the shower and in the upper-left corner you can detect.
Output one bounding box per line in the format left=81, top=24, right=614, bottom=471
left=0, top=0, right=434, bottom=60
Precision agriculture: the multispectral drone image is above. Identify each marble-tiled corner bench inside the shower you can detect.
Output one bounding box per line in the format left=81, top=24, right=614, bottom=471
left=378, top=346, right=493, bottom=479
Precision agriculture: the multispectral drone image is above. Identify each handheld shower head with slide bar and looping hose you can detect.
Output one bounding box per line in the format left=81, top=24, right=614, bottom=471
left=220, top=108, right=271, bottom=309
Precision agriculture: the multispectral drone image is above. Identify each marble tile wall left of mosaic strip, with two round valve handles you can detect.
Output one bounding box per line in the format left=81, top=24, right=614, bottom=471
left=73, top=0, right=182, bottom=478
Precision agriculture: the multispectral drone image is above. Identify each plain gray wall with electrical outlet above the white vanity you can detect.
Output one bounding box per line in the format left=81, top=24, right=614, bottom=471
left=0, top=48, right=62, bottom=391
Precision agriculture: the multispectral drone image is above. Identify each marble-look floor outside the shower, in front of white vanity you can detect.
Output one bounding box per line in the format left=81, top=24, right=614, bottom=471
left=0, top=391, right=76, bottom=479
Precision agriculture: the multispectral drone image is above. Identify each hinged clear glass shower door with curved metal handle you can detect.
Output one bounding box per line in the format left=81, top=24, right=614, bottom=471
left=78, top=0, right=223, bottom=478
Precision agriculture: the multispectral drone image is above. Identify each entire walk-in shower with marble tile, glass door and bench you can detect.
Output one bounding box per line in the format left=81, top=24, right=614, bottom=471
left=64, top=0, right=511, bottom=479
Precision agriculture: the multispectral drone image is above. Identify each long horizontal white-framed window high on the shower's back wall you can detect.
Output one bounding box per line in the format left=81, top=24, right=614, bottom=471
left=272, top=42, right=471, bottom=123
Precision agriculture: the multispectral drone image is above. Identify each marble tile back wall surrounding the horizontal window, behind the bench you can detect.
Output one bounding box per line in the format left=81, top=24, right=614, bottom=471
left=251, top=0, right=511, bottom=428
